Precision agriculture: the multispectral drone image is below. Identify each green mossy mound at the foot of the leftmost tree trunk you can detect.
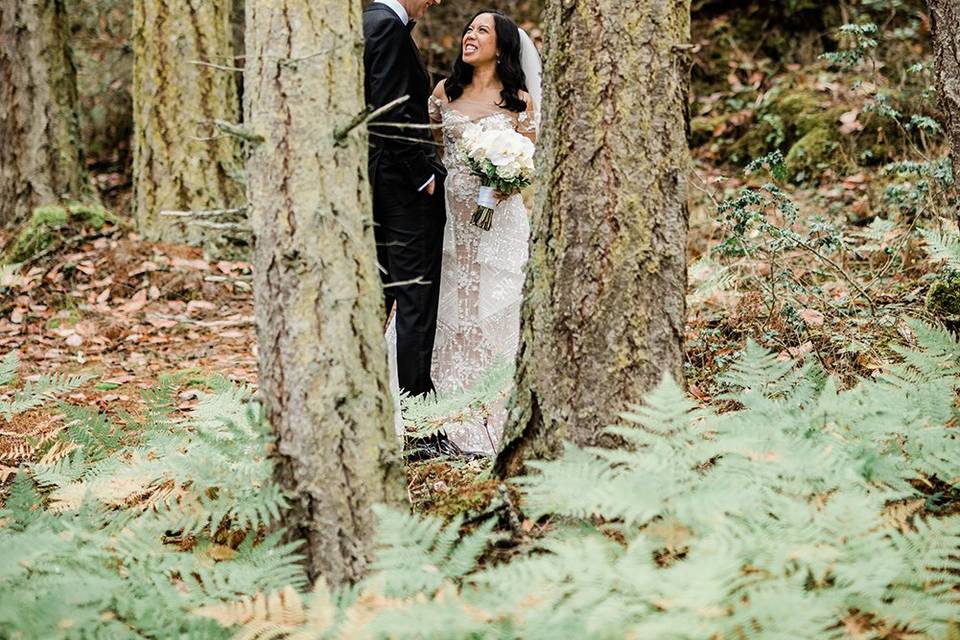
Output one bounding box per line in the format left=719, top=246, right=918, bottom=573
left=0, top=204, right=117, bottom=264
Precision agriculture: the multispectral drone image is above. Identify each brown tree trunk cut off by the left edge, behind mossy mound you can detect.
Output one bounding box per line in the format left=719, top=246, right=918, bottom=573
left=0, top=0, right=93, bottom=227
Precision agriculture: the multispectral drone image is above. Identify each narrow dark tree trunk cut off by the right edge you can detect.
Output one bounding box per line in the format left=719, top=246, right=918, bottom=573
left=929, top=0, right=960, bottom=222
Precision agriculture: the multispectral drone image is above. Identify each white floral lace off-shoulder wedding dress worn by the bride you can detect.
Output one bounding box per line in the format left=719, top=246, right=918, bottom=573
left=386, top=96, right=537, bottom=453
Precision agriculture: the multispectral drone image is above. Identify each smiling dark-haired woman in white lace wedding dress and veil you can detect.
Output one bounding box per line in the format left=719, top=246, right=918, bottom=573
left=387, top=11, right=541, bottom=453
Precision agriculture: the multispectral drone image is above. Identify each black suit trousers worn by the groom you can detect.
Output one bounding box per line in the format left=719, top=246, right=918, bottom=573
left=373, top=175, right=446, bottom=395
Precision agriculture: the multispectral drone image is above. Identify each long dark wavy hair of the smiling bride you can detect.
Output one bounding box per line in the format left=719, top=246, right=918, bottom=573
left=443, top=10, right=527, bottom=113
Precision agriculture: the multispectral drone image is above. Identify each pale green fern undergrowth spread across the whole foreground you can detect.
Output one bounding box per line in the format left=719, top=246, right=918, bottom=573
left=0, top=321, right=960, bottom=639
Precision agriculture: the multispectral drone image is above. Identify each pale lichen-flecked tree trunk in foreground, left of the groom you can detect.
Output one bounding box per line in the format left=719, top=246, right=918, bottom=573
left=244, top=0, right=403, bottom=584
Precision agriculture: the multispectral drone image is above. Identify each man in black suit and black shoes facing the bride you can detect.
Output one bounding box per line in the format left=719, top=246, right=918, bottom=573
left=363, top=0, right=459, bottom=458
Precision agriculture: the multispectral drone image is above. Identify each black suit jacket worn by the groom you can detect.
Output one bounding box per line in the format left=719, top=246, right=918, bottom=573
left=363, top=2, right=446, bottom=199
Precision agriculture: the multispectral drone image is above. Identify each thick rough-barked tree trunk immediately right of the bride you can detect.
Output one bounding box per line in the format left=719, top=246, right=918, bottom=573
left=496, top=0, right=690, bottom=475
